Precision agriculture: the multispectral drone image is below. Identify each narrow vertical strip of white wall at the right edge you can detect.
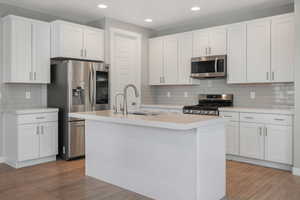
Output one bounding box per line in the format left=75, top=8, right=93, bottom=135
left=294, top=0, right=300, bottom=168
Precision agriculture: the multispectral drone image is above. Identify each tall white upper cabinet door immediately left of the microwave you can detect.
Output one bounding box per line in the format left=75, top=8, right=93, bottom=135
left=178, top=33, right=193, bottom=84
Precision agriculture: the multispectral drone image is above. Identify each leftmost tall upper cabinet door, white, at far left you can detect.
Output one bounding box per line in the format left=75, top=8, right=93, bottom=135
left=10, top=19, right=33, bottom=83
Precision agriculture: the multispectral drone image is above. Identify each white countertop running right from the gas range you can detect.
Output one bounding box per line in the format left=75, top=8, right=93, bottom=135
left=219, top=107, right=294, bottom=115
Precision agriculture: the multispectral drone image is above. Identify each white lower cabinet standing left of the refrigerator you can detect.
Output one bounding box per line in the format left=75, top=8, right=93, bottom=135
left=5, top=111, right=58, bottom=168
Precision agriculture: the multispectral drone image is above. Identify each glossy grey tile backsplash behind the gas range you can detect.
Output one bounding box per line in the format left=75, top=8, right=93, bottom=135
left=143, top=79, right=294, bottom=108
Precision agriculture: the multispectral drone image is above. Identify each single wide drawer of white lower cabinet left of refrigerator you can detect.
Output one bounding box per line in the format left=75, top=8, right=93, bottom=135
left=17, top=112, right=58, bottom=124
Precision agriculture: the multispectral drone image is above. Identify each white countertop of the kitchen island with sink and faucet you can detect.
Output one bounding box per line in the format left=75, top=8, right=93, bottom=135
left=69, top=110, right=223, bottom=130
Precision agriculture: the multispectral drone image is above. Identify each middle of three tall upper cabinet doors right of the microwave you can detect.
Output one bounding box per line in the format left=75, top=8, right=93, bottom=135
left=247, top=20, right=271, bottom=83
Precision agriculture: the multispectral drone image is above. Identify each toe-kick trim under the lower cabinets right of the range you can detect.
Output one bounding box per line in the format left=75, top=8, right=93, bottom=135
left=226, top=155, right=292, bottom=171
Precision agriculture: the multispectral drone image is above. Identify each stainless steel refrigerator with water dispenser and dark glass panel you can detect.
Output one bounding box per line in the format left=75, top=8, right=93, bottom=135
left=48, top=59, right=109, bottom=160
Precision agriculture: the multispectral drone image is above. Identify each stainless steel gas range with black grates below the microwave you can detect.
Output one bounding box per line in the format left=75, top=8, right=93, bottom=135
left=183, top=94, right=233, bottom=115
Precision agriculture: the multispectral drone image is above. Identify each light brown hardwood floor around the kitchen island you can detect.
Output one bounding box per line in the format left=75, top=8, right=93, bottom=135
left=0, top=160, right=300, bottom=200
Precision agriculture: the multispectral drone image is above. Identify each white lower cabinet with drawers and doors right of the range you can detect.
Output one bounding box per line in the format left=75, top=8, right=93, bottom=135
left=220, top=112, right=293, bottom=165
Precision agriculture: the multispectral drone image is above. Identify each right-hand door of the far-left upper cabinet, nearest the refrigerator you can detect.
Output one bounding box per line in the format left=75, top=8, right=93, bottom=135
left=32, top=22, right=51, bottom=83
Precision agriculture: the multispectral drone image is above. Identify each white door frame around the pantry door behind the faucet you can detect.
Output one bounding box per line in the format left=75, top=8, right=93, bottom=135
left=109, top=28, right=142, bottom=108
